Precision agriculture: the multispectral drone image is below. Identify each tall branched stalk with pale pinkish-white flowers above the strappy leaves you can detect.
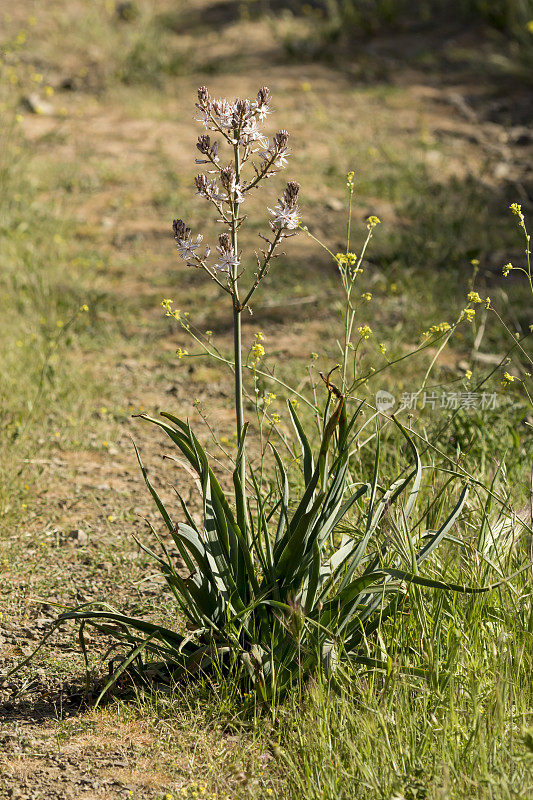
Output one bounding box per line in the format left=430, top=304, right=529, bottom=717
left=174, top=86, right=300, bottom=485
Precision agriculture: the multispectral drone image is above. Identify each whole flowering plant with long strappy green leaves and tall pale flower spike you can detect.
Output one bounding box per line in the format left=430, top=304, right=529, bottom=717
left=42, top=87, right=508, bottom=698
